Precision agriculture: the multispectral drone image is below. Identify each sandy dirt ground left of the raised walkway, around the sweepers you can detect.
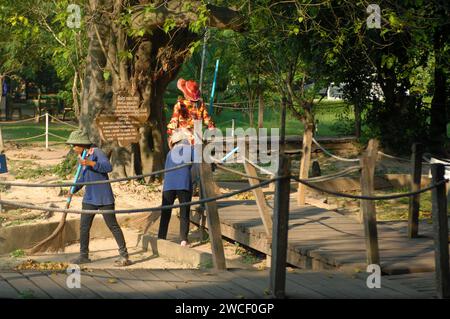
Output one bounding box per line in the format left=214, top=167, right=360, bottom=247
left=0, top=144, right=265, bottom=268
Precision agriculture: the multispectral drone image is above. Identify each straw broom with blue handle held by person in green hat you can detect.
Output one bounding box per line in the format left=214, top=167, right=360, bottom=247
left=28, top=149, right=87, bottom=254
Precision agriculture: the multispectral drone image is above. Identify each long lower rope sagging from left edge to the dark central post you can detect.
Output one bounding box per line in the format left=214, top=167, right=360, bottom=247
left=0, top=177, right=282, bottom=215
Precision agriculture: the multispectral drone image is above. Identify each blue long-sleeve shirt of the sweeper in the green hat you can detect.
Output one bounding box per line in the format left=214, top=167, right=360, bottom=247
left=74, top=148, right=114, bottom=206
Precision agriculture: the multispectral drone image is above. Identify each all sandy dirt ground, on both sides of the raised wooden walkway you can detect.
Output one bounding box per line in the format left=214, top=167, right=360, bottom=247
left=0, top=144, right=429, bottom=268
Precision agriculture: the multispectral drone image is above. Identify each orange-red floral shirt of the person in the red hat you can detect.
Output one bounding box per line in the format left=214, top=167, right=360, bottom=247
left=167, top=99, right=216, bottom=136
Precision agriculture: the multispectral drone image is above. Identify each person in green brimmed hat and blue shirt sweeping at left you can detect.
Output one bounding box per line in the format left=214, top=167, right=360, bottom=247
left=66, top=130, right=131, bottom=266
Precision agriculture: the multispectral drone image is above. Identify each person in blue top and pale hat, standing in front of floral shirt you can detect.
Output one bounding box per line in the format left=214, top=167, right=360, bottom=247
left=158, top=129, right=193, bottom=246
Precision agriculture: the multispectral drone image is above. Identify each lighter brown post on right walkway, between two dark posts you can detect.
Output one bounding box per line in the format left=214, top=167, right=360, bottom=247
left=360, top=139, right=380, bottom=265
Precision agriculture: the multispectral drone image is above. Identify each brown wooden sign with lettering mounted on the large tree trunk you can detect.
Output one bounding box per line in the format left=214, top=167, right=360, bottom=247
left=96, top=96, right=148, bottom=146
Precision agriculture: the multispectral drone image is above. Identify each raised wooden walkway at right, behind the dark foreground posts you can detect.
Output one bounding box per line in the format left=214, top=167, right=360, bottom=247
left=212, top=201, right=450, bottom=275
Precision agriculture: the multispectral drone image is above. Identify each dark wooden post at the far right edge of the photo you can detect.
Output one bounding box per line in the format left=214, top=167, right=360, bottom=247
left=431, top=164, right=450, bottom=298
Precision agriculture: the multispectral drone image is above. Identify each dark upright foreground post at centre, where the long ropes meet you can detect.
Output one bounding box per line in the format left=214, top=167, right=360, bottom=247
left=270, top=156, right=291, bottom=298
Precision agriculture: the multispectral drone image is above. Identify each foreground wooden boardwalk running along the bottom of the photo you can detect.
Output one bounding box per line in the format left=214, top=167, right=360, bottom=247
left=0, top=269, right=434, bottom=299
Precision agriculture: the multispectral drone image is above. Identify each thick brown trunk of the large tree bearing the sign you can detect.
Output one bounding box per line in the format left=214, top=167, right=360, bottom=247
left=80, top=0, right=243, bottom=177
